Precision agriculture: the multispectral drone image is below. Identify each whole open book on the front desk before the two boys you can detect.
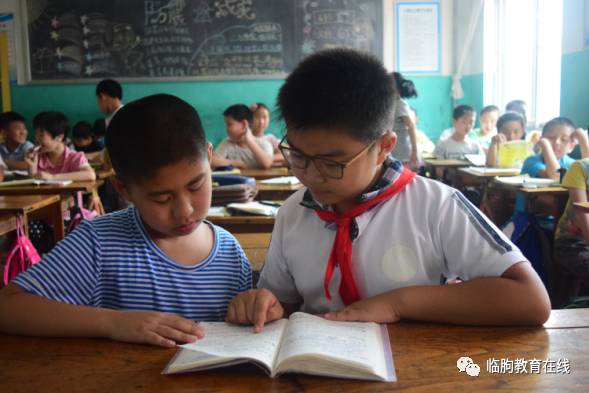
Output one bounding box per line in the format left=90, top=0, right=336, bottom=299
left=163, top=312, right=396, bottom=382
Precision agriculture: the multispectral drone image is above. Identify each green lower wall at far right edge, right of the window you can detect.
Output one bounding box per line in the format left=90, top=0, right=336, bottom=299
left=560, top=48, right=589, bottom=127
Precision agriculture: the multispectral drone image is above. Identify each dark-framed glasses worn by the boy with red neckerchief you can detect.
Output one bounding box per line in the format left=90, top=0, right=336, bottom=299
left=278, top=136, right=376, bottom=179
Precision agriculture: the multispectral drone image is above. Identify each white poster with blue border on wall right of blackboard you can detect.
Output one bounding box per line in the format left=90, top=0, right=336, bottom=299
left=396, top=2, right=441, bottom=74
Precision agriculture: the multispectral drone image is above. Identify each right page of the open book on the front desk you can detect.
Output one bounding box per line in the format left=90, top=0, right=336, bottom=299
left=277, top=313, right=385, bottom=375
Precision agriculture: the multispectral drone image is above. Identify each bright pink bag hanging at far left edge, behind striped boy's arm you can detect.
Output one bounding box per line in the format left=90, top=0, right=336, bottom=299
left=2, top=215, right=41, bottom=285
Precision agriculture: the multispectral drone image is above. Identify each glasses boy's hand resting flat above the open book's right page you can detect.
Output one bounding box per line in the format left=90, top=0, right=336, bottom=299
left=323, top=295, right=401, bottom=323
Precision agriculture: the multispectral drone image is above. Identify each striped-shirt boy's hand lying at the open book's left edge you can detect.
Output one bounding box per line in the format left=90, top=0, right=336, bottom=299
left=109, top=311, right=204, bottom=348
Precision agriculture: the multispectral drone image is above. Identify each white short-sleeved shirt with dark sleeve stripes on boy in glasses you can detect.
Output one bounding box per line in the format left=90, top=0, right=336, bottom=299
left=258, top=176, right=526, bottom=313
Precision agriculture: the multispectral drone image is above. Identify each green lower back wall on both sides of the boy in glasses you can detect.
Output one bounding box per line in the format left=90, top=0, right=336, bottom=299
left=12, top=76, right=452, bottom=144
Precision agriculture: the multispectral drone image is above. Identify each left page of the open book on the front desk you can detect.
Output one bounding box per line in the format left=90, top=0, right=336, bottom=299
left=180, top=319, right=288, bottom=369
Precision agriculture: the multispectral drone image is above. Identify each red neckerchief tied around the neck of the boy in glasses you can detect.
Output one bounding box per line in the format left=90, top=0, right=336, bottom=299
left=315, top=167, right=415, bottom=305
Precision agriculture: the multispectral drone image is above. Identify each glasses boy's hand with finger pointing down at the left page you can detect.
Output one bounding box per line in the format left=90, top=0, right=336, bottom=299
left=226, top=288, right=284, bottom=333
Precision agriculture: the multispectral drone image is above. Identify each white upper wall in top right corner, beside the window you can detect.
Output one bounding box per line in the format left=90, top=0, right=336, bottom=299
left=562, top=0, right=589, bottom=53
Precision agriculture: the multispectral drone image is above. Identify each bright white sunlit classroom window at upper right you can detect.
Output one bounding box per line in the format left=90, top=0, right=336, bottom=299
left=483, top=0, right=563, bottom=126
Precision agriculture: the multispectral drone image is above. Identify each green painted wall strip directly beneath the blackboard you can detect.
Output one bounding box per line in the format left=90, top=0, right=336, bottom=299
left=12, top=80, right=282, bottom=144
